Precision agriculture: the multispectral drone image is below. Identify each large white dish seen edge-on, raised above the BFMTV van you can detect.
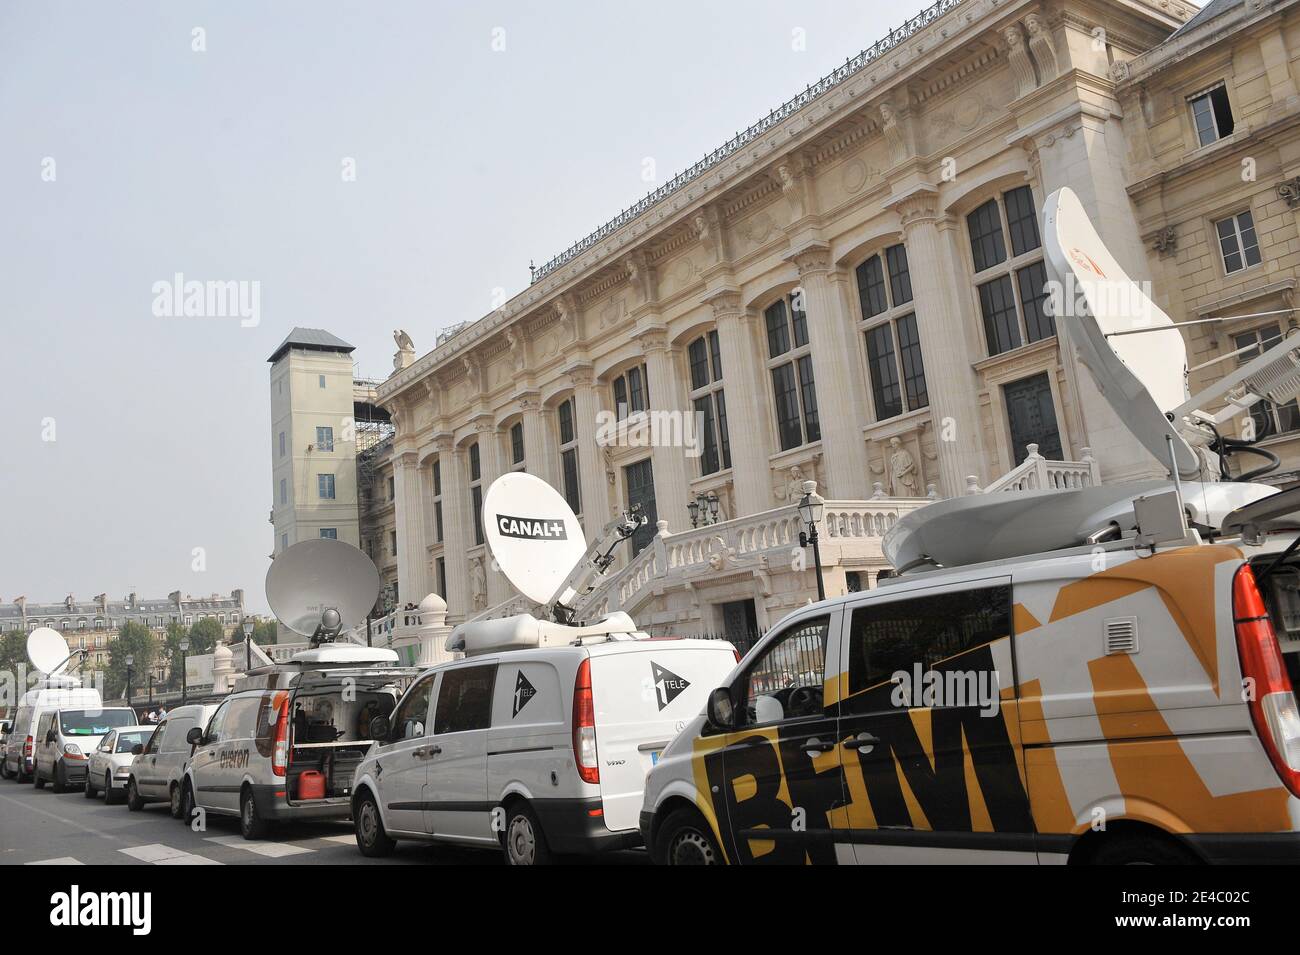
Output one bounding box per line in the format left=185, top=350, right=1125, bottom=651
left=1043, top=187, right=1200, bottom=478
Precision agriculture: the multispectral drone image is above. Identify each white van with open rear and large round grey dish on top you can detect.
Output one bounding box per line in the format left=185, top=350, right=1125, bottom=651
left=178, top=538, right=419, bottom=839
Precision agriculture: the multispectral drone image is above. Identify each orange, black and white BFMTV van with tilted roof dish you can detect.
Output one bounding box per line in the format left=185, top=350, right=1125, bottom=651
left=641, top=191, right=1300, bottom=864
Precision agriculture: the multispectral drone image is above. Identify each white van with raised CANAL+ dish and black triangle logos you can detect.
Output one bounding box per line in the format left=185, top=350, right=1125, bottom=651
left=352, top=473, right=737, bottom=865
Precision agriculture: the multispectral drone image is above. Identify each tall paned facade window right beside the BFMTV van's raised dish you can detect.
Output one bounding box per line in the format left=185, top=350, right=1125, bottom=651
left=966, top=186, right=1056, bottom=355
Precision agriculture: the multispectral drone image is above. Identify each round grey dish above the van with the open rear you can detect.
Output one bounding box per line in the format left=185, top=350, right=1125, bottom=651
left=267, top=538, right=380, bottom=637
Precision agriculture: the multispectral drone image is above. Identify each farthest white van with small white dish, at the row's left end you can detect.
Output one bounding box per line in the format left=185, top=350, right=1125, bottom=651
left=4, top=626, right=104, bottom=782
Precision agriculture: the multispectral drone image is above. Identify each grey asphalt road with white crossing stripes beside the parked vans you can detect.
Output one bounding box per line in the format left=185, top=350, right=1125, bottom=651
left=0, top=780, right=649, bottom=865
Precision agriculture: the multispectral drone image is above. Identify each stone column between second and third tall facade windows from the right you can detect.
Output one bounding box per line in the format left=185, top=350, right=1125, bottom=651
left=785, top=243, right=868, bottom=499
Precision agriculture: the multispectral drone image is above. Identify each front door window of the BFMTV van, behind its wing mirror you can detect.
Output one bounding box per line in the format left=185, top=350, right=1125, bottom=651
left=737, top=617, right=831, bottom=726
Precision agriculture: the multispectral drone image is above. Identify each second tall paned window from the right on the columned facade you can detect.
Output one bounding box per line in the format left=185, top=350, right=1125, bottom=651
left=857, top=244, right=930, bottom=421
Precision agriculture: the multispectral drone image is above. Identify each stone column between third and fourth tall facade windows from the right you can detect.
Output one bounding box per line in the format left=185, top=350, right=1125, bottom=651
left=707, top=291, right=772, bottom=526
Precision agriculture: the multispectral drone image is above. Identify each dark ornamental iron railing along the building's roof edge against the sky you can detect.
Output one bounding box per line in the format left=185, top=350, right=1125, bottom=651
left=527, top=0, right=965, bottom=283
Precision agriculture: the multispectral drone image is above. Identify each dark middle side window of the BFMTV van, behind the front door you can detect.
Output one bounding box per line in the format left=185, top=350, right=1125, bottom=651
left=845, top=585, right=1011, bottom=712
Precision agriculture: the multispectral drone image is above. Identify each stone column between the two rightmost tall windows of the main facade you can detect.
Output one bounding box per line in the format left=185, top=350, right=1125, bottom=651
left=894, top=190, right=992, bottom=498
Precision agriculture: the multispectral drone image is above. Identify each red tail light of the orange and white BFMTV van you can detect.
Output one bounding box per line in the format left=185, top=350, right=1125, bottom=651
left=1232, top=564, right=1300, bottom=796
